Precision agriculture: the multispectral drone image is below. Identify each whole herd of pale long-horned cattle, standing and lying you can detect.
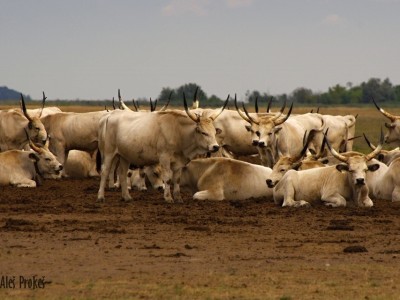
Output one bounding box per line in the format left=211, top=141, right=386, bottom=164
left=0, top=91, right=400, bottom=207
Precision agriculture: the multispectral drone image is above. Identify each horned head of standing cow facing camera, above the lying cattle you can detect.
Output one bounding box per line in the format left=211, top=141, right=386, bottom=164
left=235, top=95, right=293, bottom=148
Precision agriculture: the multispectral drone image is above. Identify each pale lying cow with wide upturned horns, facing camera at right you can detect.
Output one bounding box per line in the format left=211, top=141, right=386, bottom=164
left=274, top=132, right=383, bottom=207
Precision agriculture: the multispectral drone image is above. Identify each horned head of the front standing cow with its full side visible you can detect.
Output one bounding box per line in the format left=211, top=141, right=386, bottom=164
left=183, top=89, right=229, bottom=152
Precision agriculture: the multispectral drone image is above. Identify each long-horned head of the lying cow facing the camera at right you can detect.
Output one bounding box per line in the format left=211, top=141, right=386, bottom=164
left=326, top=130, right=384, bottom=206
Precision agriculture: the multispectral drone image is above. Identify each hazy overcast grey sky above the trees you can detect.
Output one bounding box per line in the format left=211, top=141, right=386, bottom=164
left=0, top=0, right=400, bottom=99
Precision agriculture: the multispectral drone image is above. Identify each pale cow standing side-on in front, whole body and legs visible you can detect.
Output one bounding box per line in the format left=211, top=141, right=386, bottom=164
left=97, top=97, right=229, bottom=202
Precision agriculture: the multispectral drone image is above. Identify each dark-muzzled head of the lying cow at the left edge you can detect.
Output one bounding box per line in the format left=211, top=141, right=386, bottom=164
left=29, top=139, right=63, bottom=178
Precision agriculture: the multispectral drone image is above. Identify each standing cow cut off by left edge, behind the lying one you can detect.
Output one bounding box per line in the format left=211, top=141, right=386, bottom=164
left=0, top=94, right=47, bottom=151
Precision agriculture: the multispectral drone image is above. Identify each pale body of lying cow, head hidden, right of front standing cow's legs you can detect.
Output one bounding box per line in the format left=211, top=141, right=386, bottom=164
left=181, top=157, right=272, bottom=200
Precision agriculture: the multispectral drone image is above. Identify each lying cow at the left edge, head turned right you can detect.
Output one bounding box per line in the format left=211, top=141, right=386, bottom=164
left=0, top=141, right=63, bottom=187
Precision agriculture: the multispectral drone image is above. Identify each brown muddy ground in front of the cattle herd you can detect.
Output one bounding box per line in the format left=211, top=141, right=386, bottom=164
left=0, top=178, right=400, bottom=299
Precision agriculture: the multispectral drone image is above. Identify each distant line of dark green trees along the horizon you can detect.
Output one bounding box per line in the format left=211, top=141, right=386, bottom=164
left=0, top=78, right=400, bottom=109
